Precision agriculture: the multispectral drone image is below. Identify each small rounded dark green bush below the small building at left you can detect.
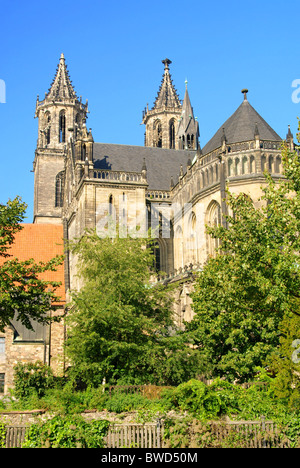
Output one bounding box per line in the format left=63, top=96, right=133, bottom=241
left=14, top=361, right=54, bottom=398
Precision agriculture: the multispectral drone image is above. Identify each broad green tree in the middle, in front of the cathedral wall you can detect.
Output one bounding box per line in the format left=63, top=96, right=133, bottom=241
left=66, top=232, right=202, bottom=385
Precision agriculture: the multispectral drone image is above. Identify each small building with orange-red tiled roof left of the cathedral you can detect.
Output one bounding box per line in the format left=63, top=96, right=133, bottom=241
left=0, top=224, right=66, bottom=393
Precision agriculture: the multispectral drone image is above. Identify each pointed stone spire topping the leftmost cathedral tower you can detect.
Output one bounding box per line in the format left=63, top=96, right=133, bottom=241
left=45, top=54, right=78, bottom=101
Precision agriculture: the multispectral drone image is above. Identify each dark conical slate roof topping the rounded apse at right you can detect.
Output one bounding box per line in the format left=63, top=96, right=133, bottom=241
left=202, top=98, right=282, bottom=154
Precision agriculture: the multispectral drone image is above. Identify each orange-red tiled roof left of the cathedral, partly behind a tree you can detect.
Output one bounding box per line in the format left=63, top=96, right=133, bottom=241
left=0, top=224, right=65, bottom=302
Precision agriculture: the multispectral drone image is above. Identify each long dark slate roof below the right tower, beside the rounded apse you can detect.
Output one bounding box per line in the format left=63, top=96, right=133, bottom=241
left=93, top=143, right=196, bottom=190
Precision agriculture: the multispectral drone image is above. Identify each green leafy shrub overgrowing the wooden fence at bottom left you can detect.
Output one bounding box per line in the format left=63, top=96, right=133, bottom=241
left=23, top=415, right=109, bottom=448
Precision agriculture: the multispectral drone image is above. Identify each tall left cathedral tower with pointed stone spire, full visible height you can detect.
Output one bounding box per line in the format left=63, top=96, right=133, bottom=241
left=33, top=54, right=88, bottom=224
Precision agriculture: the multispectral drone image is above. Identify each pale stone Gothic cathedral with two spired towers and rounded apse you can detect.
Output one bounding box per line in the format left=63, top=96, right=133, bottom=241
left=0, top=54, right=294, bottom=392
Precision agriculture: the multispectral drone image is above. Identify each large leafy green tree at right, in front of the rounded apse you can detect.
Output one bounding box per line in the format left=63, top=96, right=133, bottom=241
left=189, top=122, right=300, bottom=381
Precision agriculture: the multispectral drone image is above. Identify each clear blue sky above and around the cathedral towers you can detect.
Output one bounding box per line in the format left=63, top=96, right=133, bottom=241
left=0, top=0, right=300, bottom=222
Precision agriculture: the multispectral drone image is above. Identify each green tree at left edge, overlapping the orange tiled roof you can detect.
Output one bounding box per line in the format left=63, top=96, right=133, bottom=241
left=0, top=197, right=63, bottom=331
